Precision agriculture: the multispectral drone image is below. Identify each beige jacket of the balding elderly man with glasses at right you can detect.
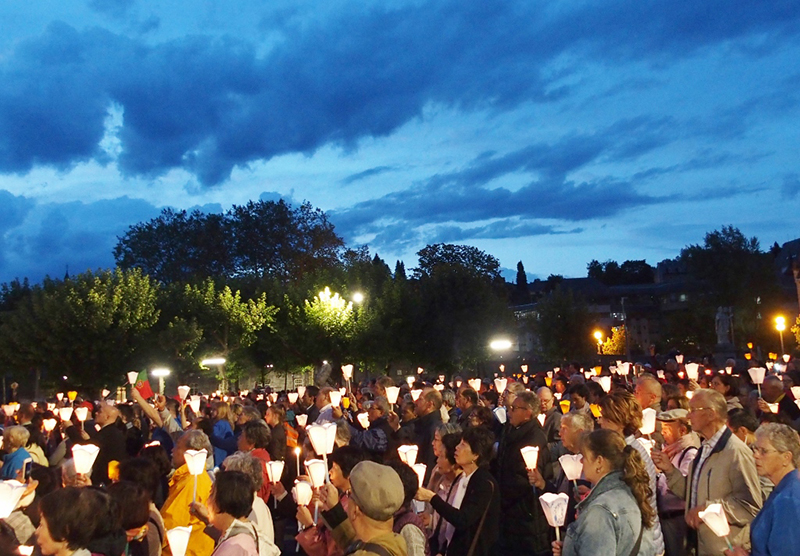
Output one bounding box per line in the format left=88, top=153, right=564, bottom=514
left=667, top=428, right=762, bottom=556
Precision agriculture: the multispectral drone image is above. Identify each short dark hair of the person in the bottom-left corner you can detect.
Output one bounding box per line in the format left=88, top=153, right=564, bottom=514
left=39, top=487, right=118, bottom=550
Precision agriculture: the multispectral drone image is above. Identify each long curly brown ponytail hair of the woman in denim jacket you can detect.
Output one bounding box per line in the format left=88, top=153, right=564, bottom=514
left=583, top=429, right=657, bottom=528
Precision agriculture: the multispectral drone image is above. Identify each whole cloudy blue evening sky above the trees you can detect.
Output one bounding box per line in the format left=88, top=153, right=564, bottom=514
left=0, top=0, right=800, bottom=281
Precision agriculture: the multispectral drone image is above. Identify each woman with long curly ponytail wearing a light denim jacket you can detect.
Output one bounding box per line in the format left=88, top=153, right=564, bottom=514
left=552, top=429, right=659, bottom=556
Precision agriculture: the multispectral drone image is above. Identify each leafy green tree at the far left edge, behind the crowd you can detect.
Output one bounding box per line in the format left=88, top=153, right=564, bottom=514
left=0, top=269, right=159, bottom=387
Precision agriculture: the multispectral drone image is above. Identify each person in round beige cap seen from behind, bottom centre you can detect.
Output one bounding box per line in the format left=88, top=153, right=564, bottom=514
left=322, top=461, right=406, bottom=556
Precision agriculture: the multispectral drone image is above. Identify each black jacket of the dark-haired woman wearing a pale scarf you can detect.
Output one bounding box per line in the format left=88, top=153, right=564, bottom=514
left=431, top=467, right=500, bottom=556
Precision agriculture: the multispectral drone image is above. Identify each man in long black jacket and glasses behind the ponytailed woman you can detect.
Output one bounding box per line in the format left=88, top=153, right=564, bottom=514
left=494, top=391, right=552, bottom=556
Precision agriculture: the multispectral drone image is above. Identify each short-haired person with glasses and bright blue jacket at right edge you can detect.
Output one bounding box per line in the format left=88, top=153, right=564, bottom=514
left=725, top=423, right=800, bottom=556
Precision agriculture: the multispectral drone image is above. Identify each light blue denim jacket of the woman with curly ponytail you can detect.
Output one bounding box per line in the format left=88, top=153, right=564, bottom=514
left=561, top=471, right=655, bottom=556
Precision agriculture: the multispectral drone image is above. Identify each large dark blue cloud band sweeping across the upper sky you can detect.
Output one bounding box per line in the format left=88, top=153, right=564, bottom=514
left=0, top=0, right=800, bottom=186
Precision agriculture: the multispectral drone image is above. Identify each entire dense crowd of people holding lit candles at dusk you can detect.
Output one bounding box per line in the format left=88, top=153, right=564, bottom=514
left=0, top=359, right=800, bottom=556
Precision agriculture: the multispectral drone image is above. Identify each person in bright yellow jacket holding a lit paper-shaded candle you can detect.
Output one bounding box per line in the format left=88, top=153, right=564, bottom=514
left=161, top=430, right=214, bottom=556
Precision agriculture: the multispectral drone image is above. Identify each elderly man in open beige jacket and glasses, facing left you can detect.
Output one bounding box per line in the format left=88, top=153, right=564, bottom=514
left=653, top=389, right=762, bottom=556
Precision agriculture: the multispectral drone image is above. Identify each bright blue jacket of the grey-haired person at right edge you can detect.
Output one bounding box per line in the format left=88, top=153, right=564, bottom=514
left=750, top=470, right=800, bottom=556
